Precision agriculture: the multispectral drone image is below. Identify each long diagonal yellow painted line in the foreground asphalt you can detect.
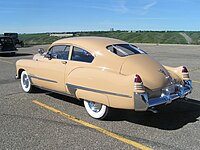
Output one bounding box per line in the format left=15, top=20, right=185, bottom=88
left=32, top=100, right=152, bottom=150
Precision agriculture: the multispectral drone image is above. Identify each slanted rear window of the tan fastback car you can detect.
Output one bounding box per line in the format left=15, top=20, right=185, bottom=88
left=107, top=44, right=145, bottom=57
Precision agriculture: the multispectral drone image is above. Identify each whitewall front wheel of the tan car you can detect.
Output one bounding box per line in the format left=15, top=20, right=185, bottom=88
left=21, top=71, right=33, bottom=93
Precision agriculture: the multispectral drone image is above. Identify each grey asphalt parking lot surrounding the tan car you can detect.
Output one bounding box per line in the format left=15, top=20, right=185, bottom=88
left=0, top=44, right=200, bottom=150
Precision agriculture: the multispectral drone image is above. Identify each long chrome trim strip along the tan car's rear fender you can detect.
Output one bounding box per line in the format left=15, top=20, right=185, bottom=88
left=66, top=84, right=132, bottom=98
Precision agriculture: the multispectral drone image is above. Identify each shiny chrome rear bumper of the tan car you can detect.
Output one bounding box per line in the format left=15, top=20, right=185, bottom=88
left=134, top=80, right=192, bottom=111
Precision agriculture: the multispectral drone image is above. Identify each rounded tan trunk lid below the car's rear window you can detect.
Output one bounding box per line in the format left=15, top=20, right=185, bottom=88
left=120, top=54, right=171, bottom=91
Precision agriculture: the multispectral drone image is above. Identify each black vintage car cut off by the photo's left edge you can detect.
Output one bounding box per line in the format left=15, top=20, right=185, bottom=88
left=0, top=36, right=17, bottom=55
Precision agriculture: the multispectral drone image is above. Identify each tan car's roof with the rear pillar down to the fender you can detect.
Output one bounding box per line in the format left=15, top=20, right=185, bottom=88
left=49, top=36, right=134, bottom=72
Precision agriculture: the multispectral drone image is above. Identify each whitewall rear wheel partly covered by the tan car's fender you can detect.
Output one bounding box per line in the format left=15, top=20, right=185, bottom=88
left=84, top=100, right=109, bottom=119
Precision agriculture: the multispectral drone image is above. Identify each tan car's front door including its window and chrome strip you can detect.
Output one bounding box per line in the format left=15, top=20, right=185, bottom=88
left=30, top=45, right=70, bottom=92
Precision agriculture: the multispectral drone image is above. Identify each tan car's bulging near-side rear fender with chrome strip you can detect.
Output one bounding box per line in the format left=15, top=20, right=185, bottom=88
left=66, top=68, right=134, bottom=109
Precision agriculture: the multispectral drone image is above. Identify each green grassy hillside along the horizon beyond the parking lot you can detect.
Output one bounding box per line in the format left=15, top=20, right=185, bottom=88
left=19, top=31, right=200, bottom=45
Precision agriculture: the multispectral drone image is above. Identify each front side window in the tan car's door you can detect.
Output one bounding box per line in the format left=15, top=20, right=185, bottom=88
left=49, top=45, right=70, bottom=60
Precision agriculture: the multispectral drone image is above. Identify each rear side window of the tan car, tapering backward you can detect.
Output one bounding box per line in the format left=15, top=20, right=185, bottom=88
left=71, top=46, right=94, bottom=63
